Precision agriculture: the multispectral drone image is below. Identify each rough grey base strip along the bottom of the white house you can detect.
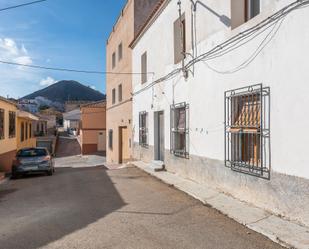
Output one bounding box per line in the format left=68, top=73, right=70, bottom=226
left=134, top=144, right=309, bottom=226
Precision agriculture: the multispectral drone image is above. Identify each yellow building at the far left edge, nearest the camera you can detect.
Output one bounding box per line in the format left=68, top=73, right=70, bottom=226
left=0, top=97, right=17, bottom=173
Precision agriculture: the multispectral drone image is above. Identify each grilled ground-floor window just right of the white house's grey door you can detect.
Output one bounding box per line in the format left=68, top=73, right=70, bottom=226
left=170, top=102, right=189, bottom=158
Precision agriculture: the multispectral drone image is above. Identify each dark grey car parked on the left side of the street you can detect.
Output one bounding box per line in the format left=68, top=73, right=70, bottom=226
left=12, top=148, right=55, bottom=178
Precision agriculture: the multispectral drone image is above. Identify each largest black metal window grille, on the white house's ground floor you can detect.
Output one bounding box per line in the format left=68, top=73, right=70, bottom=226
left=225, top=84, right=271, bottom=179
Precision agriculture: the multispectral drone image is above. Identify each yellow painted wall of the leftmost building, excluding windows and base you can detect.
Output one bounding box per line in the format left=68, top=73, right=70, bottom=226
left=0, top=99, right=17, bottom=155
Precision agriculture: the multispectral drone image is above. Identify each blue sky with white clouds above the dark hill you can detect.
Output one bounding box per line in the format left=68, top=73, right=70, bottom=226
left=0, top=0, right=126, bottom=98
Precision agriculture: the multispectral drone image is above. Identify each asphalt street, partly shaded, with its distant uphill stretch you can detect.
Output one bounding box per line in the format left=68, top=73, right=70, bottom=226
left=0, top=136, right=281, bottom=249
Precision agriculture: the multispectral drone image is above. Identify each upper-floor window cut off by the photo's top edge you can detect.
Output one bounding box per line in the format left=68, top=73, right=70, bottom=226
left=231, top=0, right=261, bottom=29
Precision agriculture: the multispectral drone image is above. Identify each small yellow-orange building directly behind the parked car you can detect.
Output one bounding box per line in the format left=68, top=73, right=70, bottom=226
left=16, top=110, right=39, bottom=150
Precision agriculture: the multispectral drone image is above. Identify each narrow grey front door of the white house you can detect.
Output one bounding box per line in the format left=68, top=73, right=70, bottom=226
left=154, top=111, right=165, bottom=161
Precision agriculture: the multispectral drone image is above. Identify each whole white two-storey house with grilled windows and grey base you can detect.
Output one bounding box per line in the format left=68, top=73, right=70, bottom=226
left=131, top=0, right=309, bottom=225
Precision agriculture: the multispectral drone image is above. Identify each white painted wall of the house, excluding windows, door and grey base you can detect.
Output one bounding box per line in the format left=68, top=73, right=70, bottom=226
left=133, top=0, right=309, bottom=179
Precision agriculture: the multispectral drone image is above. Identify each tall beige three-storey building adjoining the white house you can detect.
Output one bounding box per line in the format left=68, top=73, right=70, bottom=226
left=106, top=0, right=158, bottom=163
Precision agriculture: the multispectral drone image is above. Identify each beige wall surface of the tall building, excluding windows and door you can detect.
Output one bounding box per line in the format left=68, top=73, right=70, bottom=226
left=106, top=0, right=134, bottom=163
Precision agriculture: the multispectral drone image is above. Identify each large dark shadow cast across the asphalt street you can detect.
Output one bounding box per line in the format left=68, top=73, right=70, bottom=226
left=0, top=167, right=126, bottom=249
